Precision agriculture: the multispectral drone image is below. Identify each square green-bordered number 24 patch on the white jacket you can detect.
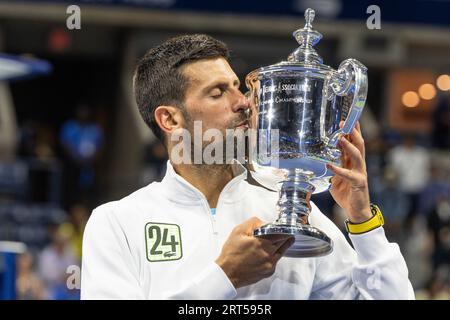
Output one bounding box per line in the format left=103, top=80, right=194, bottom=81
left=145, top=222, right=183, bottom=262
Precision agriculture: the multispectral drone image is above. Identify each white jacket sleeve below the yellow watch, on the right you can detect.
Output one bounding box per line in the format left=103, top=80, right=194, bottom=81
left=310, top=206, right=415, bottom=300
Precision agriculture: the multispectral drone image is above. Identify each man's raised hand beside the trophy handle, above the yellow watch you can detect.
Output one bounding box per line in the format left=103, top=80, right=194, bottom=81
left=327, top=122, right=372, bottom=223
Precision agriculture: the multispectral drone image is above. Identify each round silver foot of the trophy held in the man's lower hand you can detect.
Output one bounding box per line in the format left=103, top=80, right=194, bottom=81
left=253, top=223, right=333, bottom=258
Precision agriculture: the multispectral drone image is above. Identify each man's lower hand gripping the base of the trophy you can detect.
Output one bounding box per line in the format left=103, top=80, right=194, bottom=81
left=216, top=217, right=294, bottom=289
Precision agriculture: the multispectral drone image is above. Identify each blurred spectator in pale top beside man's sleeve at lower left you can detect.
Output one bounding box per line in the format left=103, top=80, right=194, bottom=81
left=39, top=225, right=77, bottom=300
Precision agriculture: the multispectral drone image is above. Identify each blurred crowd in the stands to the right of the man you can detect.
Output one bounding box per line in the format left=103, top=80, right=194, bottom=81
left=313, top=94, right=450, bottom=299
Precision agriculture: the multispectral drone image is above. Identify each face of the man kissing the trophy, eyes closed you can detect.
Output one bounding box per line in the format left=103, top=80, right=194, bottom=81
left=176, top=58, right=249, bottom=162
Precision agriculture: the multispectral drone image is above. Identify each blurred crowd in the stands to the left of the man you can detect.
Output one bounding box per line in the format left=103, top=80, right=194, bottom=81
left=0, top=104, right=103, bottom=300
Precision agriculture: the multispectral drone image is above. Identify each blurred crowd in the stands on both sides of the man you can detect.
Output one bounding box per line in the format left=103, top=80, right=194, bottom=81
left=0, top=90, right=450, bottom=299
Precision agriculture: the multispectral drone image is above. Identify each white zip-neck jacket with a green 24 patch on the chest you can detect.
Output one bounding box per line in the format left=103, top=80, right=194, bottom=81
left=81, top=162, right=414, bottom=299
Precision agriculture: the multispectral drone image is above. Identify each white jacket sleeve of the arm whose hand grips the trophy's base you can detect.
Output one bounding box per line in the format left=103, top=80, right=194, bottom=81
left=81, top=207, right=236, bottom=300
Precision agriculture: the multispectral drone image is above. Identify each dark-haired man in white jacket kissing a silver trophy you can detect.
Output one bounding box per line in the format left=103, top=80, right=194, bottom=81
left=81, top=35, right=414, bottom=299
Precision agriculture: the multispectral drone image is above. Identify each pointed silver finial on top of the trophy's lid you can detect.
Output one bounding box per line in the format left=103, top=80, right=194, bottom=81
left=288, top=8, right=323, bottom=64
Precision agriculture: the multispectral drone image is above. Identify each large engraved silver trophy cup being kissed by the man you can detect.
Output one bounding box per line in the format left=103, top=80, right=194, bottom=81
left=246, top=9, right=367, bottom=257
